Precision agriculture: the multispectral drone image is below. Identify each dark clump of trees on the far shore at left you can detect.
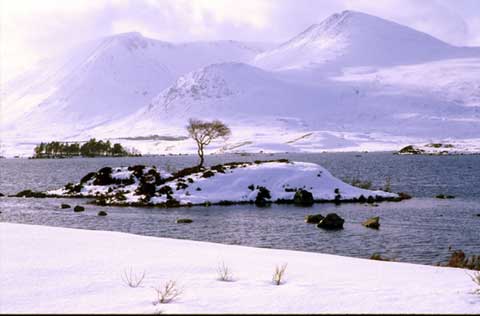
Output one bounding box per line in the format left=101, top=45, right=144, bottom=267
left=32, top=138, right=141, bottom=159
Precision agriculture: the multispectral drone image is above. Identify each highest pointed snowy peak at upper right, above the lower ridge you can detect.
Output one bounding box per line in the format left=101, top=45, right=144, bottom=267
left=255, top=11, right=480, bottom=70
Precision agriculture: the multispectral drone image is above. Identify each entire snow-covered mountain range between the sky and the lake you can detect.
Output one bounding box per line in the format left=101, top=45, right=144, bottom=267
left=2, top=11, right=480, bottom=157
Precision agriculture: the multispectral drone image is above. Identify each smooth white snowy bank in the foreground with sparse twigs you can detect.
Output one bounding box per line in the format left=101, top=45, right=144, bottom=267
left=0, top=223, right=480, bottom=314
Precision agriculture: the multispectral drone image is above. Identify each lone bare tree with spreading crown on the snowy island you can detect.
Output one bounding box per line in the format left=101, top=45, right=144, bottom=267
left=187, top=119, right=231, bottom=167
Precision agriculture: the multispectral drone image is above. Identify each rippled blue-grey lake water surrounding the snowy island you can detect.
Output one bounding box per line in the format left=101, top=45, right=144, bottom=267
left=0, top=153, right=480, bottom=264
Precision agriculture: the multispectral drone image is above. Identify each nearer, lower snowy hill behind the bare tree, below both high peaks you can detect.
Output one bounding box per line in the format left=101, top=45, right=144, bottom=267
left=84, top=59, right=480, bottom=153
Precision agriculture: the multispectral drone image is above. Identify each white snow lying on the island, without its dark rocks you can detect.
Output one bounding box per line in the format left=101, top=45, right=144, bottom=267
left=47, top=162, right=398, bottom=205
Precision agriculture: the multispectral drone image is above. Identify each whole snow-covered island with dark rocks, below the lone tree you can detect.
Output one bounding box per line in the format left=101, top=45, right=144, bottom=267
left=42, top=159, right=405, bottom=207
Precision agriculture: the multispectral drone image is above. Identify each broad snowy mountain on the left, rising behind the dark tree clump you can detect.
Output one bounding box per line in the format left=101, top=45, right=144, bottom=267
left=0, top=33, right=268, bottom=137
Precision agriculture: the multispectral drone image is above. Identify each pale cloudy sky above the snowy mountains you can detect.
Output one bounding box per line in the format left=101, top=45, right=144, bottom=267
left=0, top=0, right=480, bottom=81
